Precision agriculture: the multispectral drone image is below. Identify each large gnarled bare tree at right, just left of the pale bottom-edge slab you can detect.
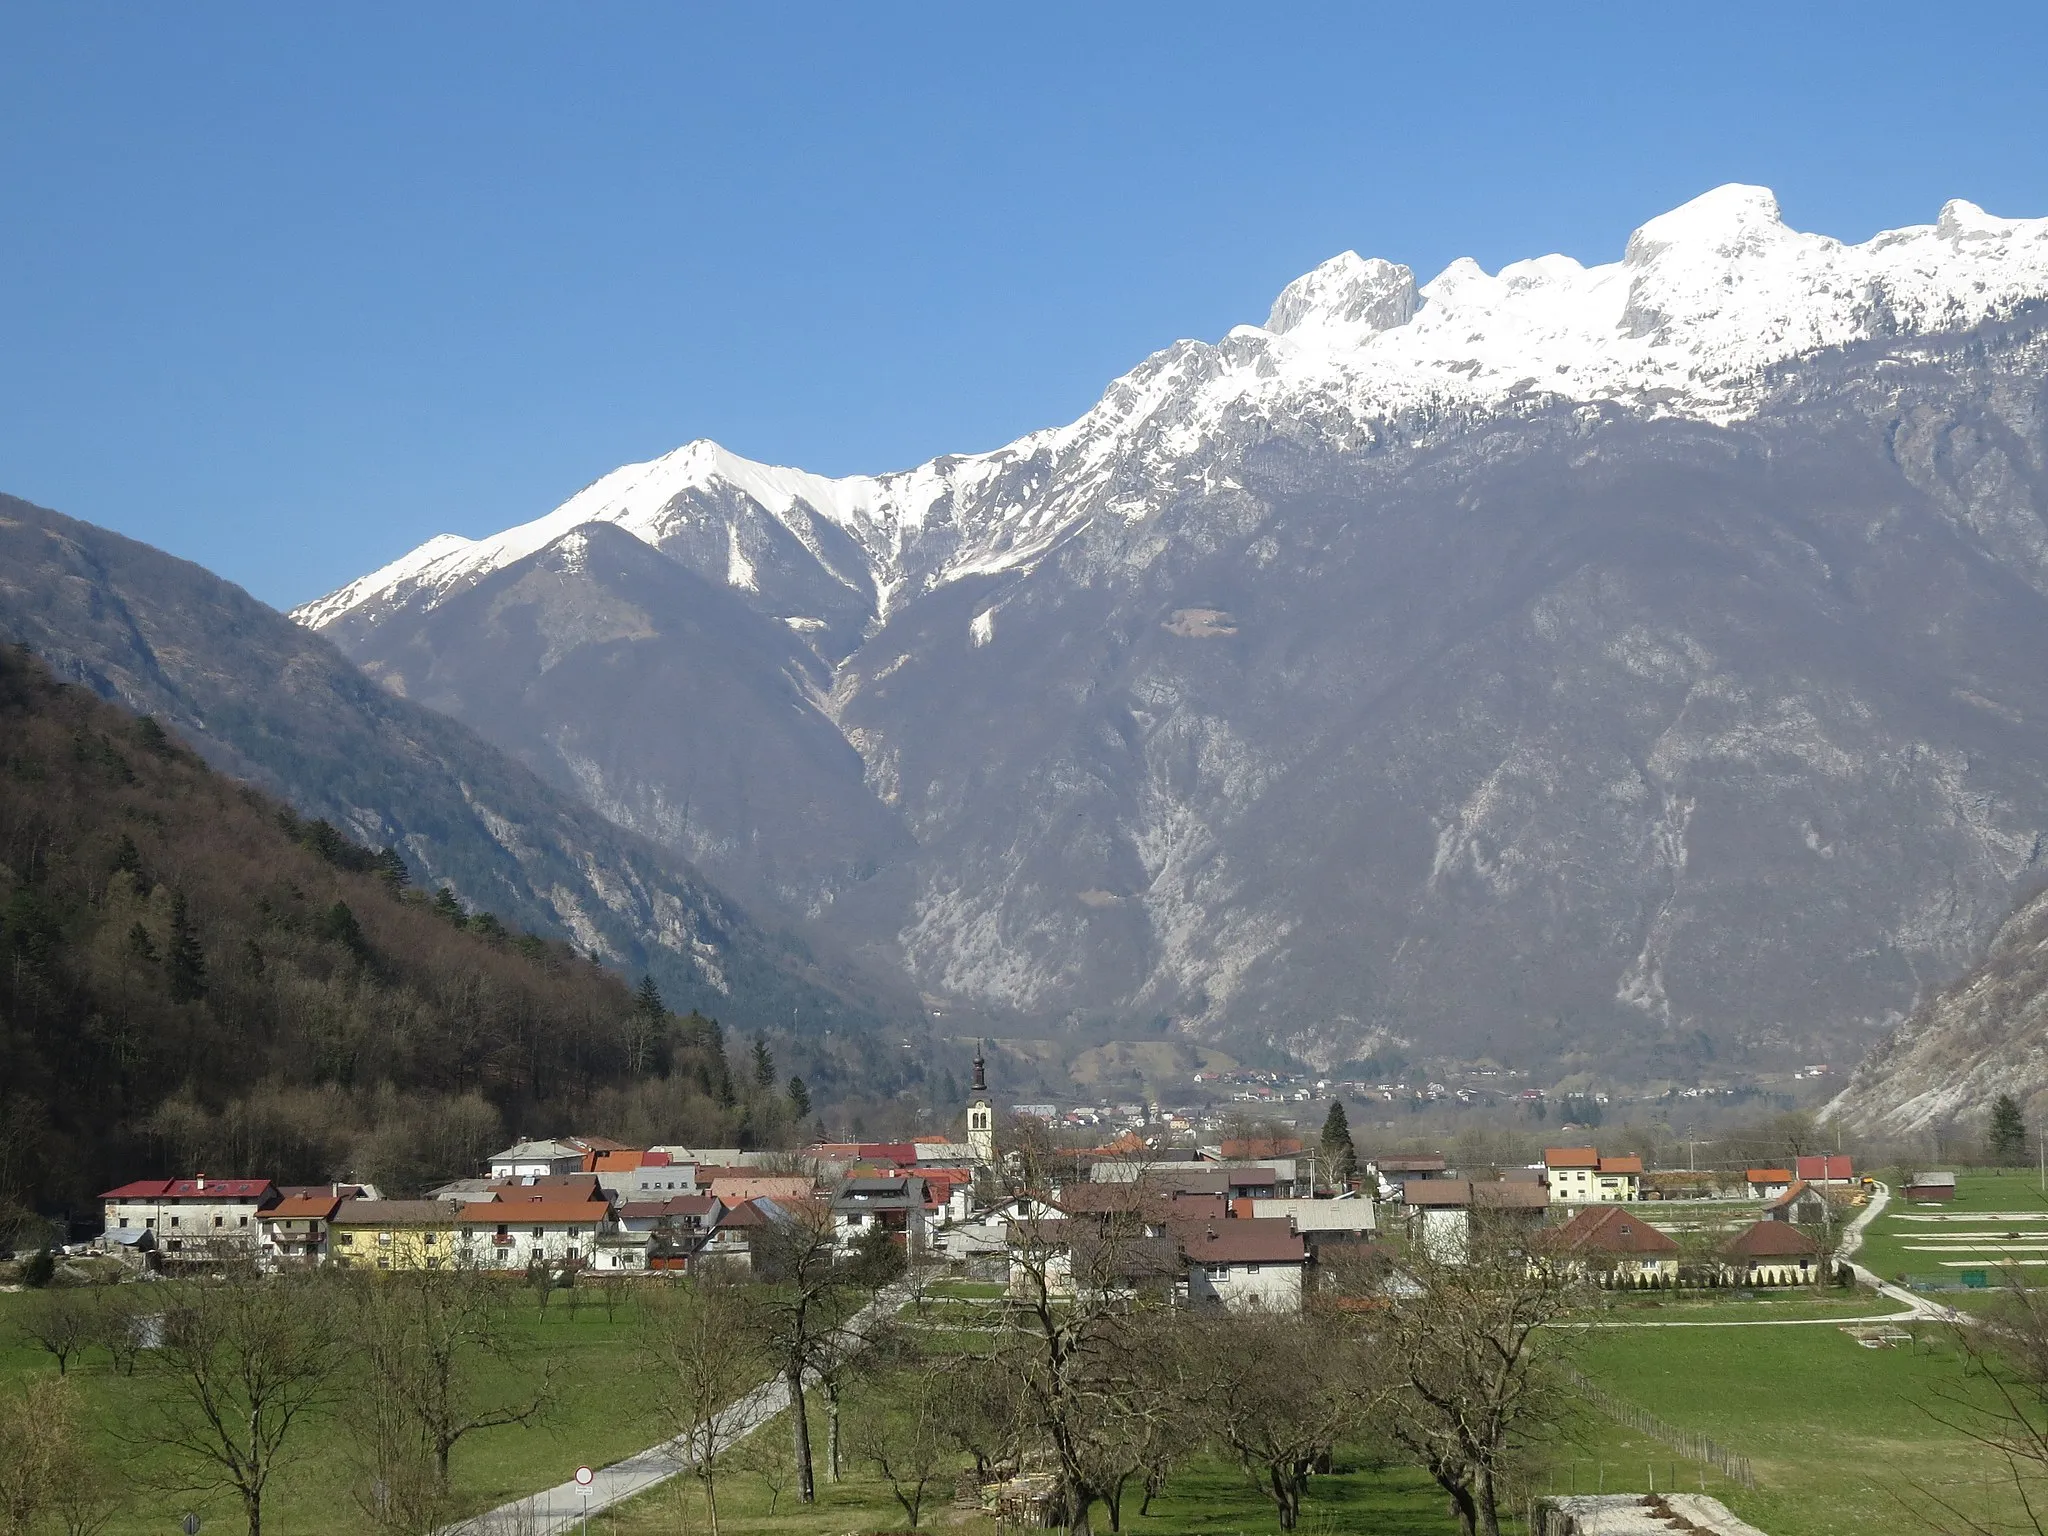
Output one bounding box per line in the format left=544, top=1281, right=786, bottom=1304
left=1378, top=1210, right=1581, bottom=1536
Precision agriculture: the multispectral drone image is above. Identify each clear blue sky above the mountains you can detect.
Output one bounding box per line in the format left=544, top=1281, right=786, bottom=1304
left=0, top=4, right=2048, bottom=606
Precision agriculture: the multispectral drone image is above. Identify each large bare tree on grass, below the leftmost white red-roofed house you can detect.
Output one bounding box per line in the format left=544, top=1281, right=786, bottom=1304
left=139, top=1276, right=342, bottom=1536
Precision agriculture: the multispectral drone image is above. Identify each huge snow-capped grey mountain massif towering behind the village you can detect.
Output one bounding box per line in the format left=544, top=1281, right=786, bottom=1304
left=297, top=186, right=2048, bottom=1073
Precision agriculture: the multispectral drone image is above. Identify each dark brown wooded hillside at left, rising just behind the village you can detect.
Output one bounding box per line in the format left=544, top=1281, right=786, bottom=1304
left=0, top=647, right=788, bottom=1241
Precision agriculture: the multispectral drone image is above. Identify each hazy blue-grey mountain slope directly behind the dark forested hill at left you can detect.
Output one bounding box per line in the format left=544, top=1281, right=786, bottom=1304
left=0, top=496, right=897, bottom=1028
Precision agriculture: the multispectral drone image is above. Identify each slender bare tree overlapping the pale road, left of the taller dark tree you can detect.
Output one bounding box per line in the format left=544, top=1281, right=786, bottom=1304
left=641, top=1280, right=766, bottom=1536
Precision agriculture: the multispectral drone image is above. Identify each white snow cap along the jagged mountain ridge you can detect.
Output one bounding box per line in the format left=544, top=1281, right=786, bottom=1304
left=293, top=184, right=2048, bottom=629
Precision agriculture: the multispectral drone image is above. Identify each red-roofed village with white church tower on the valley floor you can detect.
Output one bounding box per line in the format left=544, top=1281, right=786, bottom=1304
left=79, top=1057, right=1875, bottom=1313
